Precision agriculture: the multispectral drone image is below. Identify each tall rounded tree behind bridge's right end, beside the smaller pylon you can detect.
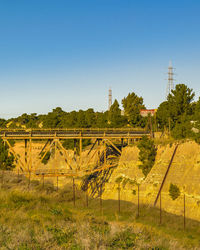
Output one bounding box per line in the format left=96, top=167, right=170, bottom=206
left=122, top=92, right=145, bottom=127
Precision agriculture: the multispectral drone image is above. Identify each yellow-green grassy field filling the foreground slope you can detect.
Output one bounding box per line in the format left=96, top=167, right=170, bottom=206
left=0, top=174, right=200, bottom=249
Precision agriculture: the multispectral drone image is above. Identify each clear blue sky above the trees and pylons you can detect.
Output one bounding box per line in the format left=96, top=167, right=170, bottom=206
left=0, top=0, right=200, bottom=118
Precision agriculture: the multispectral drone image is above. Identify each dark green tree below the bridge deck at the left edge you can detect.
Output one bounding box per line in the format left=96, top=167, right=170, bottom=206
left=0, top=138, right=15, bottom=170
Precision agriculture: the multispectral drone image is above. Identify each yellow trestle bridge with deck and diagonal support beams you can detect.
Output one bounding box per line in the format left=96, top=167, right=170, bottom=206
left=0, top=128, right=151, bottom=177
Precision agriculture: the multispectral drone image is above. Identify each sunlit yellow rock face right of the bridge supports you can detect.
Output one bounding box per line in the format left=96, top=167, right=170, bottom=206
left=103, top=141, right=200, bottom=220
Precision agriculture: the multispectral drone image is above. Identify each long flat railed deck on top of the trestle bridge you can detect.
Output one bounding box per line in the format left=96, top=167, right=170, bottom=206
left=0, top=128, right=150, bottom=139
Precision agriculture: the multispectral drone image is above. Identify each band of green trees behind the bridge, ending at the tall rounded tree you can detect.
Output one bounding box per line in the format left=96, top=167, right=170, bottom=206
left=0, top=93, right=146, bottom=128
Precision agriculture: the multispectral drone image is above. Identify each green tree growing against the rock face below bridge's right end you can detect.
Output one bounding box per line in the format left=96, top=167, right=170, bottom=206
left=138, top=136, right=157, bottom=177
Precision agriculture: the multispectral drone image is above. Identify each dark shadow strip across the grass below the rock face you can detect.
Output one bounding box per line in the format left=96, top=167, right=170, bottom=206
left=69, top=194, right=200, bottom=246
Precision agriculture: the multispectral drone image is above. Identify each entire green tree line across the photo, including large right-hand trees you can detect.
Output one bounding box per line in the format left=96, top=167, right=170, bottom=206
left=0, top=84, right=200, bottom=141
